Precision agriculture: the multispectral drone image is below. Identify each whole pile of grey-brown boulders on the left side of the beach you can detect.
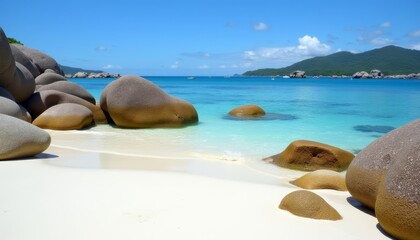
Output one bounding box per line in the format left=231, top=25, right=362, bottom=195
left=0, top=28, right=198, bottom=160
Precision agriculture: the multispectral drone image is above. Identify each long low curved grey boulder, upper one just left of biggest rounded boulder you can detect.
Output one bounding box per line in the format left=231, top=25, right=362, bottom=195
left=38, top=81, right=96, bottom=104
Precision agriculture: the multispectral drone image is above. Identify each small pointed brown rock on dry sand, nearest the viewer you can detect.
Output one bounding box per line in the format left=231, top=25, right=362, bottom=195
left=279, top=190, right=342, bottom=221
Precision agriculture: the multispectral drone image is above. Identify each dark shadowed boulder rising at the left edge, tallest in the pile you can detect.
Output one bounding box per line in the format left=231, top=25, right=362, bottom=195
left=0, top=28, right=35, bottom=102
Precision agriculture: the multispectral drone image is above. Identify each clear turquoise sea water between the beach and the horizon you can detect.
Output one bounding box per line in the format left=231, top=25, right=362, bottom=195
left=71, top=77, right=420, bottom=159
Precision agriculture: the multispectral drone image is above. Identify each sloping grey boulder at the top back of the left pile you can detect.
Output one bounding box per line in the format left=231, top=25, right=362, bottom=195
left=14, top=44, right=64, bottom=76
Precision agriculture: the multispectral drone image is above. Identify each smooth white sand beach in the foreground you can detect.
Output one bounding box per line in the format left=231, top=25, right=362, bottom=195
left=0, top=127, right=388, bottom=240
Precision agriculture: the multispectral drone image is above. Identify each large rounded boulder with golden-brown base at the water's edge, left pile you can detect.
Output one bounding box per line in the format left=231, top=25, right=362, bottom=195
left=100, top=75, right=198, bottom=128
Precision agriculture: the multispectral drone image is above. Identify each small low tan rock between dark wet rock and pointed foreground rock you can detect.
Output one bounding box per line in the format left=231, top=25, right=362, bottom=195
left=290, top=169, right=347, bottom=191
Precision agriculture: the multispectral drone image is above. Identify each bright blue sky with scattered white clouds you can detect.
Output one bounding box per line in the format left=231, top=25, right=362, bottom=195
left=0, top=0, right=420, bottom=76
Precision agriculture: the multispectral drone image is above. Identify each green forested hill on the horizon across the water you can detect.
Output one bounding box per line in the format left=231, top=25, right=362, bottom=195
left=243, top=46, right=420, bottom=76
